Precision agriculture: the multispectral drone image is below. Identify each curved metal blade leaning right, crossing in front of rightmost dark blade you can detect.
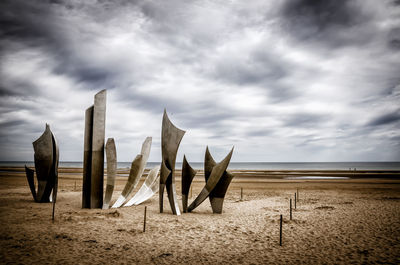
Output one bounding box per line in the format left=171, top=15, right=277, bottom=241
left=188, top=147, right=233, bottom=212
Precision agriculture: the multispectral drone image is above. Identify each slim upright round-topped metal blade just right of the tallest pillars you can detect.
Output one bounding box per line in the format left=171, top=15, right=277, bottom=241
left=103, top=138, right=117, bottom=209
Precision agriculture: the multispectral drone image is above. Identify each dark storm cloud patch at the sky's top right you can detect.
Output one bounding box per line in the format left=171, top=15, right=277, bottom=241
left=282, top=0, right=373, bottom=47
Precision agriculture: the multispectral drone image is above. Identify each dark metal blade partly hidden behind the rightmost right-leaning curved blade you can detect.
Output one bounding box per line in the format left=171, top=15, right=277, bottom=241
left=204, top=146, right=234, bottom=213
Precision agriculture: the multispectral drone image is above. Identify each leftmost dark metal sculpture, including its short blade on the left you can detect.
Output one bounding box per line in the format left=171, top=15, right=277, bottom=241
left=25, top=124, right=59, bottom=202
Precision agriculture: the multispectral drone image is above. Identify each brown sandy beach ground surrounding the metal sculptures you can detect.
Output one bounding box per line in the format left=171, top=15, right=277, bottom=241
left=0, top=170, right=400, bottom=264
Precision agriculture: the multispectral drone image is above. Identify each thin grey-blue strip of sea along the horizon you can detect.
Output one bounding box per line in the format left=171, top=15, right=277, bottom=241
left=0, top=161, right=400, bottom=170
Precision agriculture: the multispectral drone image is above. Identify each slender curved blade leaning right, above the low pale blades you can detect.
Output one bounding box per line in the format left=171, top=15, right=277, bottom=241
left=111, top=137, right=152, bottom=208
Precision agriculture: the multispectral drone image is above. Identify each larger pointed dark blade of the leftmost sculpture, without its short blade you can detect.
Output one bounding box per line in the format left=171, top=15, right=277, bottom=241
left=32, top=124, right=54, bottom=202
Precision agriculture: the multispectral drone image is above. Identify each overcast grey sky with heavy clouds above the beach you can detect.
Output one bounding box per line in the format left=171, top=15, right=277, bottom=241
left=0, top=0, right=400, bottom=162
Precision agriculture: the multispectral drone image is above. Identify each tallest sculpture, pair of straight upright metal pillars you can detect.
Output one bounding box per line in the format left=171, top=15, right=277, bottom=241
left=82, top=90, right=106, bottom=208
